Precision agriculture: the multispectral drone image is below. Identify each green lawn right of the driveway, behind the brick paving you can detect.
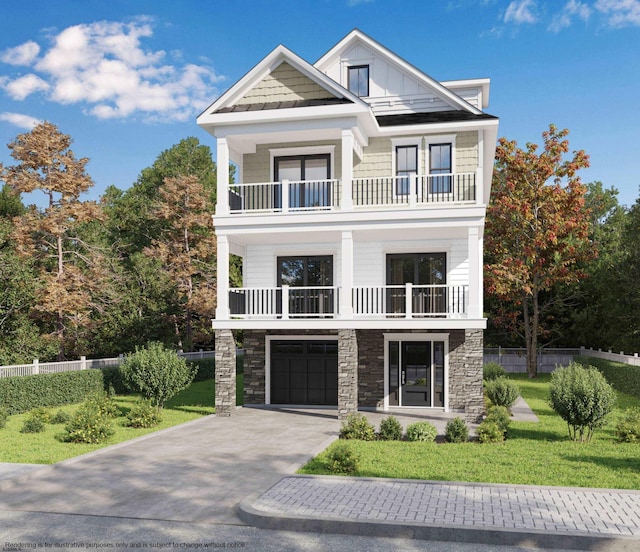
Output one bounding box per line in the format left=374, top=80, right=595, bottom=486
left=299, top=375, right=640, bottom=489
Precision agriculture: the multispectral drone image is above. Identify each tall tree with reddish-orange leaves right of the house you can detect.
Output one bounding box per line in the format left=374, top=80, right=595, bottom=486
left=485, top=125, right=595, bottom=377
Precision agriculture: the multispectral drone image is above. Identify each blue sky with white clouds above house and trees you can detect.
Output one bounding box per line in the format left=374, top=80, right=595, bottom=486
left=0, top=0, right=640, bottom=205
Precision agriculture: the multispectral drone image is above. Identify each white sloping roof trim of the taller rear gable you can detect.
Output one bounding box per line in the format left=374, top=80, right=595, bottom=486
left=314, top=29, right=482, bottom=115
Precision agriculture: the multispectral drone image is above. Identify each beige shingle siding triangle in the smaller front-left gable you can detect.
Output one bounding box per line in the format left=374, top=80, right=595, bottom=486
left=236, top=62, right=335, bottom=105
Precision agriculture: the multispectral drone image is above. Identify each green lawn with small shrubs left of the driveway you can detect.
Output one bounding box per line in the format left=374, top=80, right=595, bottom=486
left=0, top=374, right=242, bottom=464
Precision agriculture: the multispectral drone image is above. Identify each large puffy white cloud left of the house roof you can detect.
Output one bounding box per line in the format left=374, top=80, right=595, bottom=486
left=0, top=21, right=223, bottom=120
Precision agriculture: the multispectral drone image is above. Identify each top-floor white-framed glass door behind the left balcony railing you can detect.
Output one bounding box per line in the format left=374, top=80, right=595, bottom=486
left=274, top=153, right=332, bottom=209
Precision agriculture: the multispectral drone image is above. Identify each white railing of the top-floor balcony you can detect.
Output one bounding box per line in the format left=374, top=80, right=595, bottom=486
left=229, top=173, right=477, bottom=213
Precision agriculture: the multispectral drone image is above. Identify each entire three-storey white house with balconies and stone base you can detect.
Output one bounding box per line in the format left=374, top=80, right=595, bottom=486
left=198, top=30, right=498, bottom=418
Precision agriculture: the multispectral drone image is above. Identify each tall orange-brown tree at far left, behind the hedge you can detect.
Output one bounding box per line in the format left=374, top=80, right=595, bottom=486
left=5, top=122, right=103, bottom=360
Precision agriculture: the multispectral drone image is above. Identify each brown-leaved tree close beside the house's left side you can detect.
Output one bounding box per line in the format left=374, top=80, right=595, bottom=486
left=145, top=176, right=216, bottom=350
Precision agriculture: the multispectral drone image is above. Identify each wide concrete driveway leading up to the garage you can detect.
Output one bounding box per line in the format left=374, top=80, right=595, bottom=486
left=0, top=408, right=340, bottom=524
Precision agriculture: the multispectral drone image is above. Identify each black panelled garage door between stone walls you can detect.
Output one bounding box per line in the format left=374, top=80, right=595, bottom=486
left=271, top=341, right=338, bottom=406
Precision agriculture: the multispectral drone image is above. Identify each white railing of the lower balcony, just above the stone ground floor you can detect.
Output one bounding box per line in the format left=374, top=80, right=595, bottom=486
left=229, top=284, right=469, bottom=320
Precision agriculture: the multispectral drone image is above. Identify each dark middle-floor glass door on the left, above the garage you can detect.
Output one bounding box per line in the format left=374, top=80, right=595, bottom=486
left=278, top=255, right=335, bottom=316
